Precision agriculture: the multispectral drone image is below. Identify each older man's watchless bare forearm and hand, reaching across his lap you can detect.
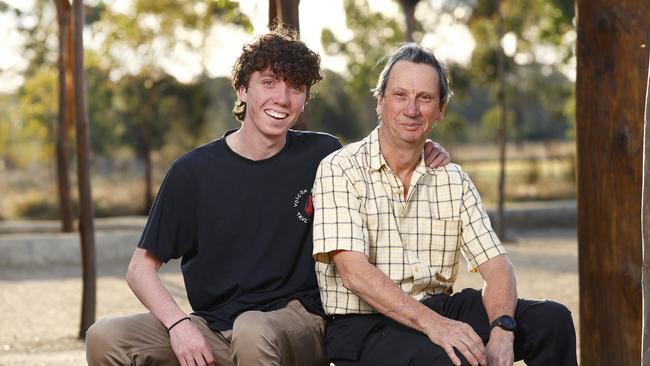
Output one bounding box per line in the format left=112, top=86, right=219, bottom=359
left=330, top=250, right=486, bottom=365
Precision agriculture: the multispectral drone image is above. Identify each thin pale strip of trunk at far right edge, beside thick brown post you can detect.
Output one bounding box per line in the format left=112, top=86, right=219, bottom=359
left=641, top=52, right=650, bottom=366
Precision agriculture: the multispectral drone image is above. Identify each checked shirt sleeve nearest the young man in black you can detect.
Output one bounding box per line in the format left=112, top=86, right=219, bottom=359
left=313, top=159, right=368, bottom=263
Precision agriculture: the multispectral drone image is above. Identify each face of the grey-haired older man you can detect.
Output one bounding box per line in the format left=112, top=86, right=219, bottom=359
left=377, top=61, right=447, bottom=147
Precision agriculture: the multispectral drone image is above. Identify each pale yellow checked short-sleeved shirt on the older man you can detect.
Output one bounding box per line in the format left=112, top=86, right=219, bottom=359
left=313, top=127, right=505, bottom=314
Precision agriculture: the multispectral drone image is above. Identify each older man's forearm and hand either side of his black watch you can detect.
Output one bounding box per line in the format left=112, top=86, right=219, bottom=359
left=478, top=255, right=517, bottom=366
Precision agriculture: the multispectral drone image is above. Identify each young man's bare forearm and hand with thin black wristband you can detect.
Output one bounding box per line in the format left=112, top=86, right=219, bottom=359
left=126, top=248, right=214, bottom=366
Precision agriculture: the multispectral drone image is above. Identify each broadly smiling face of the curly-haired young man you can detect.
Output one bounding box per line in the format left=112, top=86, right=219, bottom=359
left=237, top=68, right=307, bottom=138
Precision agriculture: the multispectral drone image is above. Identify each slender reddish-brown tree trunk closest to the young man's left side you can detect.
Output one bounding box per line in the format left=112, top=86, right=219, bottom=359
left=72, top=0, right=97, bottom=338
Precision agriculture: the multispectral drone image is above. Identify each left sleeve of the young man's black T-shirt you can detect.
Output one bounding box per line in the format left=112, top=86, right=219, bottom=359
left=138, top=161, right=196, bottom=262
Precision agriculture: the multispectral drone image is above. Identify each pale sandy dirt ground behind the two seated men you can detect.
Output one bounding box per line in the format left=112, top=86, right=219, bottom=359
left=0, top=229, right=579, bottom=366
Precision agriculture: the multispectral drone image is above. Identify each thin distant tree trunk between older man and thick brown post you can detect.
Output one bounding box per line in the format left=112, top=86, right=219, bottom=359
left=497, top=4, right=508, bottom=240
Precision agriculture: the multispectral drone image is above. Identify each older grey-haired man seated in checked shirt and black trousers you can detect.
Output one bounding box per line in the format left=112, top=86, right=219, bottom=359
left=314, top=43, right=576, bottom=366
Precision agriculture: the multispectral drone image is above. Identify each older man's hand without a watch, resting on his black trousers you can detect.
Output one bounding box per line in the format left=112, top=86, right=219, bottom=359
left=427, top=319, right=487, bottom=366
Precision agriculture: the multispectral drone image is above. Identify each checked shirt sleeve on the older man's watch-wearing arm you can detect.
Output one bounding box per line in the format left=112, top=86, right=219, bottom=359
left=460, top=172, right=506, bottom=272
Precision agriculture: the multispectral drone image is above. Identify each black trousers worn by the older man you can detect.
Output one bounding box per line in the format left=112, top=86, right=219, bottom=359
left=325, top=289, right=577, bottom=366
